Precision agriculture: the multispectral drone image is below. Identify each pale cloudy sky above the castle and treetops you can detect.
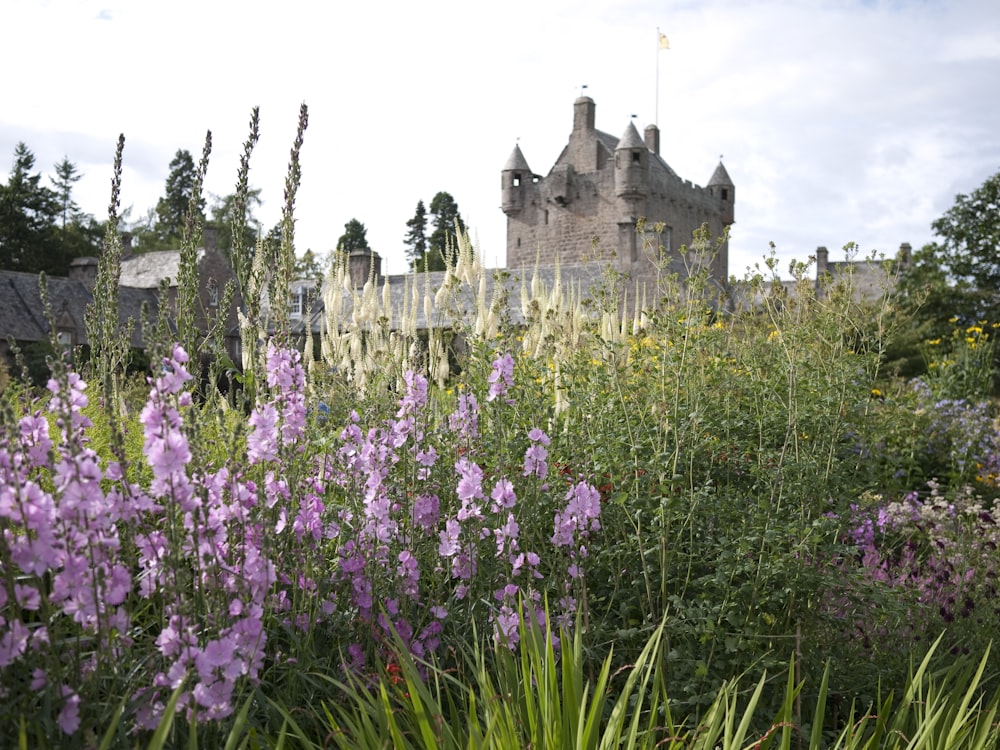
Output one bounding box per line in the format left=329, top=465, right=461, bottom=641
left=0, top=0, right=1000, bottom=277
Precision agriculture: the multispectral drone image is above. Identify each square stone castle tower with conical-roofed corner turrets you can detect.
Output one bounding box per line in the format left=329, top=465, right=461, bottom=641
left=501, top=96, right=736, bottom=285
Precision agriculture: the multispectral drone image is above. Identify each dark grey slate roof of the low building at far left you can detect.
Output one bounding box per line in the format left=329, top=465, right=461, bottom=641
left=0, top=271, right=157, bottom=346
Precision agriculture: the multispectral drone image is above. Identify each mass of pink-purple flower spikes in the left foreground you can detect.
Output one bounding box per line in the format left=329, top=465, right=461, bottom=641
left=0, top=338, right=600, bottom=734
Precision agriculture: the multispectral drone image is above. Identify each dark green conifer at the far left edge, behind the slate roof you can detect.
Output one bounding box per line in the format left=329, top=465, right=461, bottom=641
left=0, top=142, right=62, bottom=276
